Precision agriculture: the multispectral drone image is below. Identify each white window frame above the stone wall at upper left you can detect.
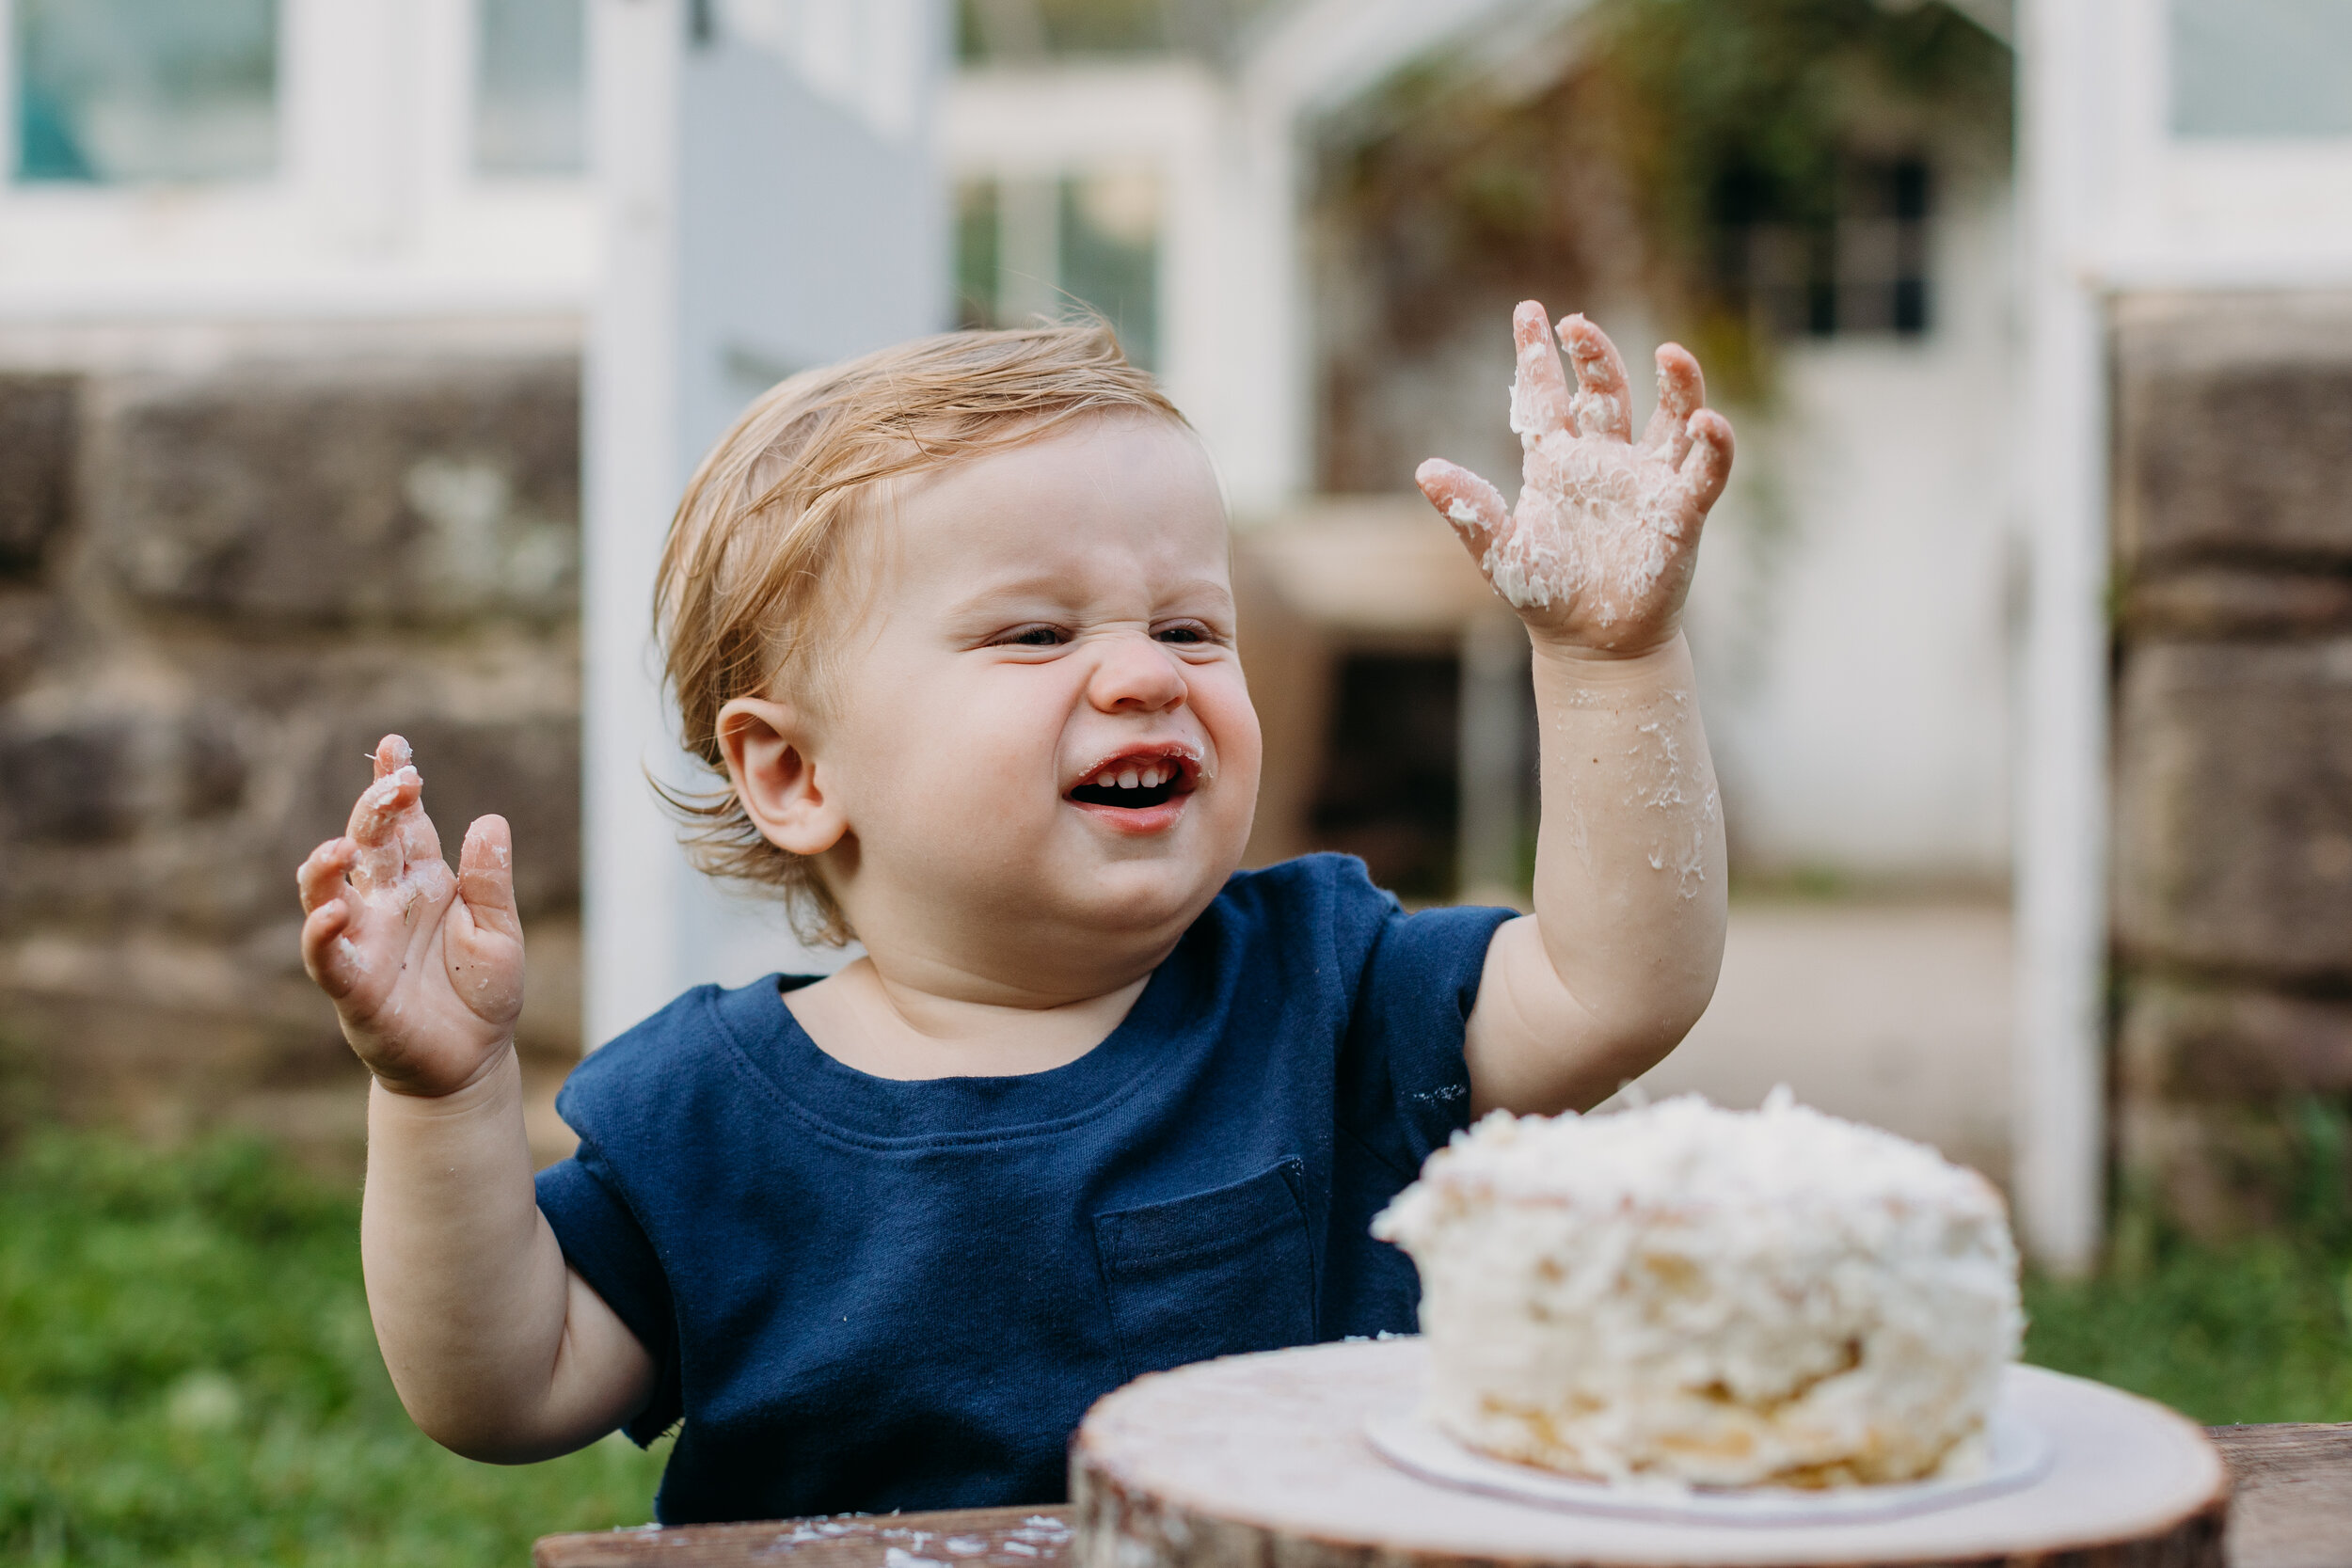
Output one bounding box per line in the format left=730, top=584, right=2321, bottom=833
left=0, top=0, right=597, bottom=322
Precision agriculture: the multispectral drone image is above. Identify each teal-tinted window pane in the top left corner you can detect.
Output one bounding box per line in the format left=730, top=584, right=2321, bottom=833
left=14, top=0, right=278, bottom=183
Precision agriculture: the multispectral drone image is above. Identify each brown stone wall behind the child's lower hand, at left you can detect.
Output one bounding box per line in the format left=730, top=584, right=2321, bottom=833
left=0, top=348, right=581, bottom=1143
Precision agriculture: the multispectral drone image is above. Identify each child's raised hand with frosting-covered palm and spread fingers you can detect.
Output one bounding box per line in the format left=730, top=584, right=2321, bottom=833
left=1416, top=301, right=1731, bottom=656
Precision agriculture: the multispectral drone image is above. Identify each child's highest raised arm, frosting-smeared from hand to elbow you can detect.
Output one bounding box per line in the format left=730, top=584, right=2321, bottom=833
left=1419, top=301, right=1731, bottom=1112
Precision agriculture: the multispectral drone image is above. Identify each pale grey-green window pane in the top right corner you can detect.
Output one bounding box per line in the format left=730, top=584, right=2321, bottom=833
left=2171, top=0, right=2352, bottom=136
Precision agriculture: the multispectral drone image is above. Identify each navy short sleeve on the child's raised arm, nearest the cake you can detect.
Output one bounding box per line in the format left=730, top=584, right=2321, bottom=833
left=1336, top=863, right=1518, bottom=1180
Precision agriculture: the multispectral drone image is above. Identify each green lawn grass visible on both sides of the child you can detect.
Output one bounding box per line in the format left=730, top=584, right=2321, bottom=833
left=0, top=1133, right=2352, bottom=1568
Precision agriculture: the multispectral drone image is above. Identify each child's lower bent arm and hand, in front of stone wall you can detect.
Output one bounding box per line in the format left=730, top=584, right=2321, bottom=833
left=301, top=736, right=654, bottom=1463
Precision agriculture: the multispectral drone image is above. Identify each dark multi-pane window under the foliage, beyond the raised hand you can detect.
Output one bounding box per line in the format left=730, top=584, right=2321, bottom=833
left=1717, top=157, right=1931, bottom=339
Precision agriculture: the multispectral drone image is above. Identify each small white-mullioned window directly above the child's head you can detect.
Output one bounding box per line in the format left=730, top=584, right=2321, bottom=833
left=955, top=169, right=1160, bottom=369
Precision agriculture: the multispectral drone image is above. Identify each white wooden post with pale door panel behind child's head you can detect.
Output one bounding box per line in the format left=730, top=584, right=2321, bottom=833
left=583, top=0, right=950, bottom=1044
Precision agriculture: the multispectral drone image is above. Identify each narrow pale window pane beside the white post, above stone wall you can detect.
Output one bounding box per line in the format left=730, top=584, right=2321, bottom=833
left=473, top=0, right=588, bottom=174
